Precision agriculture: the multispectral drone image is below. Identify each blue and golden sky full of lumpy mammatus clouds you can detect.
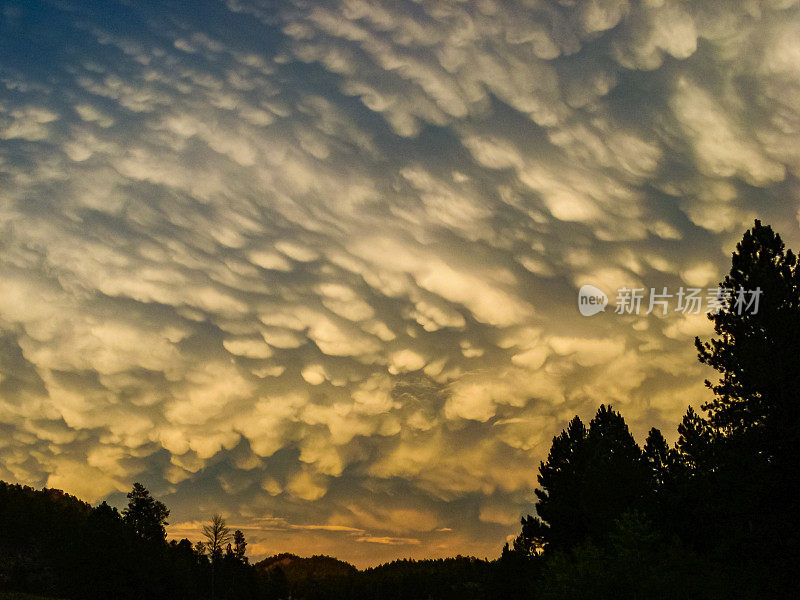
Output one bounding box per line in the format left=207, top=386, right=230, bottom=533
left=0, top=0, right=800, bottom=567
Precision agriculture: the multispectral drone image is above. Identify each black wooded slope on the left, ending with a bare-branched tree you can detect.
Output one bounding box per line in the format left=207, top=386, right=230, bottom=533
left=0, top=482, right=263, bottom=600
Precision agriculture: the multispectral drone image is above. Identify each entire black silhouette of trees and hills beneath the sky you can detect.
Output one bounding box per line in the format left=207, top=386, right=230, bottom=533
left=0, top=221, right=800, bottom=600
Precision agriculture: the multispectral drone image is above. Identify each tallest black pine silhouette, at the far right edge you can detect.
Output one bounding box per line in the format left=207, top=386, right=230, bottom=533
left=682, top=221, right=800, bottom=585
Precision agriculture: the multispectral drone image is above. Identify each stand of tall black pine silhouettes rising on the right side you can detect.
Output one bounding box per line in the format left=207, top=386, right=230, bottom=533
left=503, top=221, right=800, bottom=598
